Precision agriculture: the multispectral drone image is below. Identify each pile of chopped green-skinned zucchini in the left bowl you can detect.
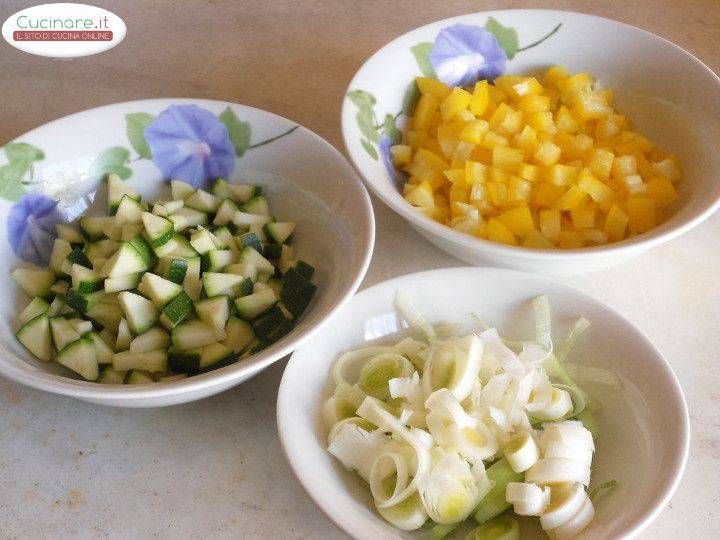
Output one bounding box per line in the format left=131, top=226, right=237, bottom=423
left=12, top=175, right=317, bottom=384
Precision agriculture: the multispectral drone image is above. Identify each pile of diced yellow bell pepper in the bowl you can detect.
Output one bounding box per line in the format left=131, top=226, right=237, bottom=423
left=390, top=66, right=682, bottom=249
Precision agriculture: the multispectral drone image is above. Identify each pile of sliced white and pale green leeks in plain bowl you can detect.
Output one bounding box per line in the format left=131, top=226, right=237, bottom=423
left=323, top=295, right=596, bottom=540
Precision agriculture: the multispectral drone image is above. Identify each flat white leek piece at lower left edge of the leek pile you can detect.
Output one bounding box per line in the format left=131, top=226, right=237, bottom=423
left=328, top=423, right=388, bottom=481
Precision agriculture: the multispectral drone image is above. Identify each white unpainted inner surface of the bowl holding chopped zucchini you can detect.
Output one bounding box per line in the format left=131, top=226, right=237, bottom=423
left=0, top=100, right=374, bottom=395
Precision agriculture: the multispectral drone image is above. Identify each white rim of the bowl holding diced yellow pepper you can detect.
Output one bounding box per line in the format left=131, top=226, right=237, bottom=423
left=340, top=9, right=720, bottom=262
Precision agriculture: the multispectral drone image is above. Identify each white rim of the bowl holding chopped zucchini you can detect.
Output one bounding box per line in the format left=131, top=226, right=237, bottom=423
left=0, top=97, right=375, bottom=400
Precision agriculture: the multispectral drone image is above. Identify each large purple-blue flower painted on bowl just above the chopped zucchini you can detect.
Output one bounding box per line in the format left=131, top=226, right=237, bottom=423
left=145, top=105, right=235, bottom=186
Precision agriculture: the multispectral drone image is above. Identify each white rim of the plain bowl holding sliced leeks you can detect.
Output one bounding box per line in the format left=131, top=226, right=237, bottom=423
left=276, top=266, right=691, bottom=538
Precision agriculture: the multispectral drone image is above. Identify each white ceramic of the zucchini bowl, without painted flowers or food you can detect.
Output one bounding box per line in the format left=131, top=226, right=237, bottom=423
left=0, top=99, right=375, bottom=407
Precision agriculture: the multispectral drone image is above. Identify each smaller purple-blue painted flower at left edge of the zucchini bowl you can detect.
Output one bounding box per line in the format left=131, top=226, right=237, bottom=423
left=7, top=193, right=62, bottom=266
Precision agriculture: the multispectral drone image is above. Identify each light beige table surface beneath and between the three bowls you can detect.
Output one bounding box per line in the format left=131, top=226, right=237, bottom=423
left=0, top=0, right=720, bottom=539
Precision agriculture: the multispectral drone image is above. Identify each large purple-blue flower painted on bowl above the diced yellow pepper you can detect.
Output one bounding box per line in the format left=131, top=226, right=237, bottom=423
left=429, top=23, right=507, bottom=87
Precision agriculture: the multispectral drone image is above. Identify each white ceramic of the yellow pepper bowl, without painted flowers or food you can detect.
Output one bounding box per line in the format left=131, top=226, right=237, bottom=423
left=342, top=10, right=720, bottom=274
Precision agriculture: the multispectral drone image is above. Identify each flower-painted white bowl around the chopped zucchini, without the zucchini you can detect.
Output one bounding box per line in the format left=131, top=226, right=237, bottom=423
left=0, top=99, right=375, bottom=407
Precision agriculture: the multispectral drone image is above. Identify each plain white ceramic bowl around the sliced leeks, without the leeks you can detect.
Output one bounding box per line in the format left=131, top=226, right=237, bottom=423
left=277, top=268, right=690, bottom=539
